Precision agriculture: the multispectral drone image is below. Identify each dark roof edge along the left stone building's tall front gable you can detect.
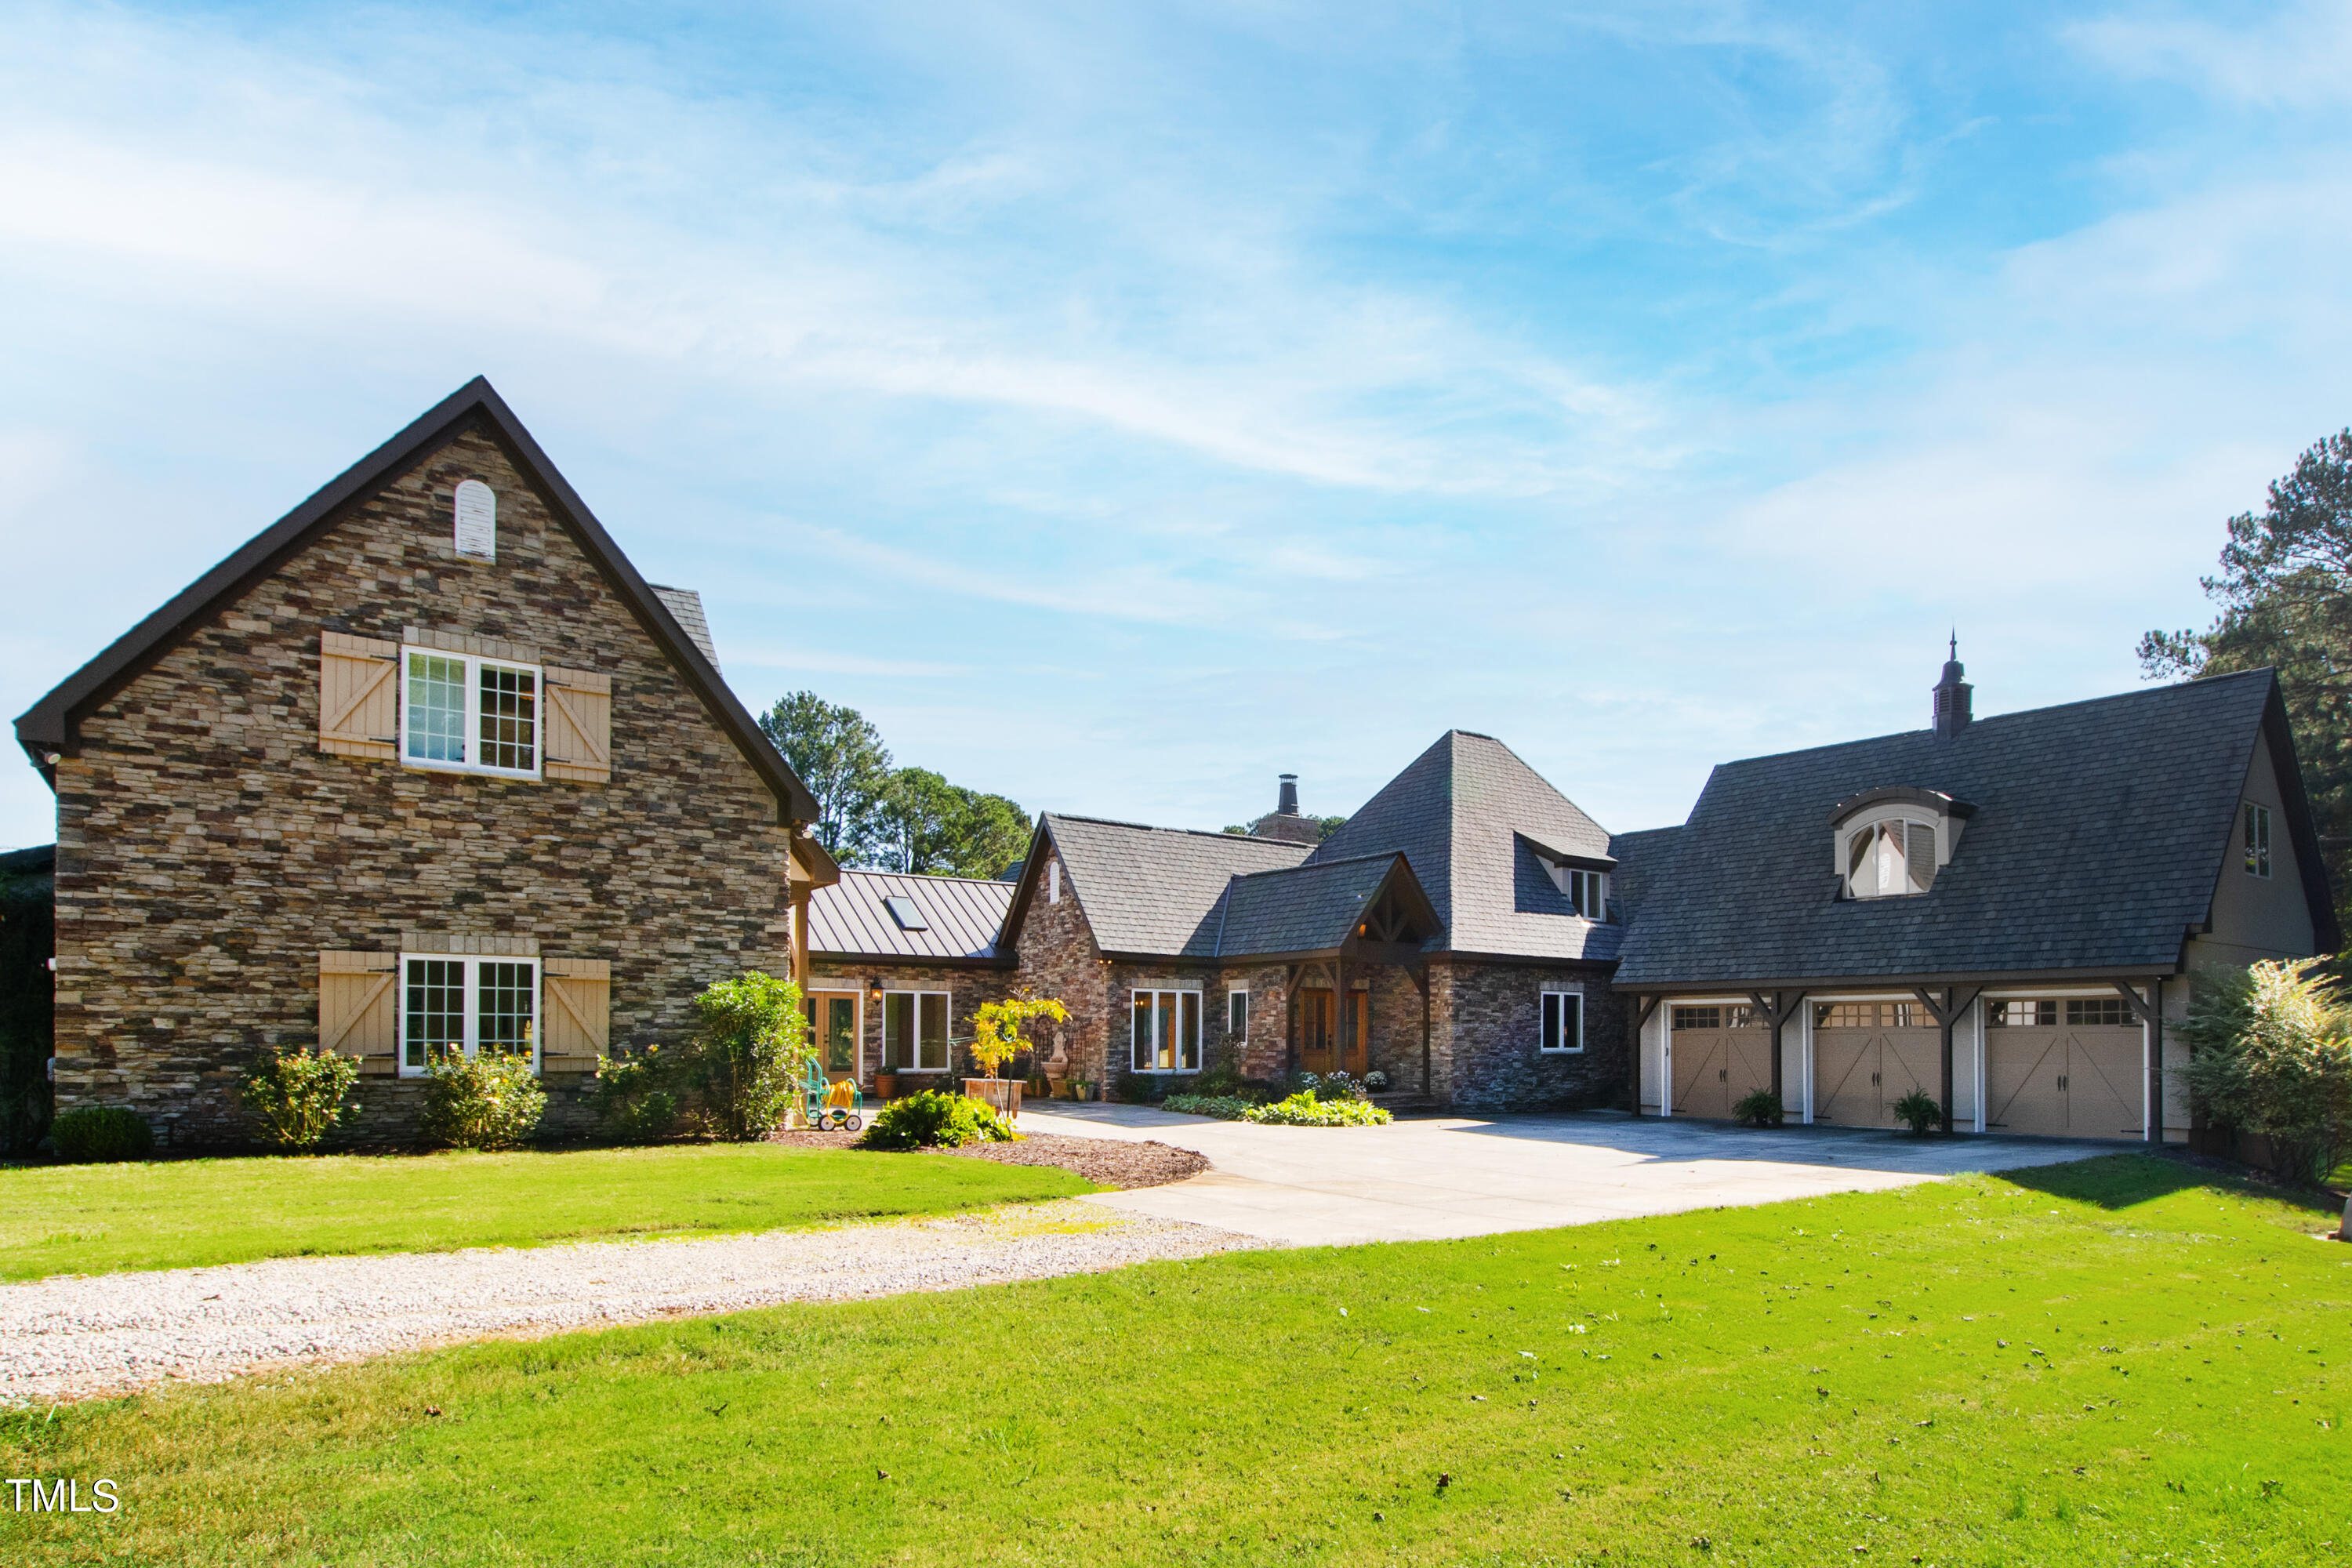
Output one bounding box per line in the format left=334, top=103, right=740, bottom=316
left=16, top=376, right=816, bottom=822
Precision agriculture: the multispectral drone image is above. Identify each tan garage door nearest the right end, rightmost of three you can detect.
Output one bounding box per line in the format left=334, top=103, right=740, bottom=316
left=1985, top=999, right=2140, bottom=1138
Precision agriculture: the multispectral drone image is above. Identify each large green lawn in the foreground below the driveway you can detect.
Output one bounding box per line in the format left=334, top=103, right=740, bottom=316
left=0, top=1156, right=2352, bottom=1568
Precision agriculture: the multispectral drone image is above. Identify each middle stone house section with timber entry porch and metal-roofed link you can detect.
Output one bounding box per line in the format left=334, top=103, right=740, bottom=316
left=790, top=731, right=1625, bottom=1107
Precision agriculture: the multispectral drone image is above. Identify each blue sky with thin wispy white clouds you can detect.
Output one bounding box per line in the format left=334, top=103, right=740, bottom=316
left=0, top=0, right=2352, bottom=844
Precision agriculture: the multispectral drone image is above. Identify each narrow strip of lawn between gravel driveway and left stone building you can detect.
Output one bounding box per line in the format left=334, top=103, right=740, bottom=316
left=0, top=1145, right=1094, bottom=1279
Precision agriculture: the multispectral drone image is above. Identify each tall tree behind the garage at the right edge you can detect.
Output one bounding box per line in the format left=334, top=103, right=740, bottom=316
left=2140, top=430, right=2352, bottom=919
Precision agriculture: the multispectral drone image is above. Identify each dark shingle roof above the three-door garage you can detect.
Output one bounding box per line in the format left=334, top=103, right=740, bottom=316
left=1616, top=670, right=2338, bottom=985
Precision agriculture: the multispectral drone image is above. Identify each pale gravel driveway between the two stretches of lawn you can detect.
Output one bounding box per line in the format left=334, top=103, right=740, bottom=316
left=0, top=1199, right=1265, bottom=1403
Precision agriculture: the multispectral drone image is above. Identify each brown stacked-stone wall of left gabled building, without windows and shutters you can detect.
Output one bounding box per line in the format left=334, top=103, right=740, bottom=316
left=56, top=428, right=790, bottom=1145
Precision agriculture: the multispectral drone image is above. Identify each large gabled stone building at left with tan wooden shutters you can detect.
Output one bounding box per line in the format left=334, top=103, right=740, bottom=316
left=16, top=381, right=837, bottom=1142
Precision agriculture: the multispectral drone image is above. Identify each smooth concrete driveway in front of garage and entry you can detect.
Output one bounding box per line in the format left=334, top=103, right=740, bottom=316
left=1021, top=1102, right=2140, bottom=1243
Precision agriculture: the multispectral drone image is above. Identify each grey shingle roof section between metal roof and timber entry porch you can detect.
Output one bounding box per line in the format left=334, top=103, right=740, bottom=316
left=1044, top=813, right=1310, bottom=959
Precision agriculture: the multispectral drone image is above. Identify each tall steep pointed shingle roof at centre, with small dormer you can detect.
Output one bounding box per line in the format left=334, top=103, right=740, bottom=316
left=1312, top=729, right=1623, bottom=959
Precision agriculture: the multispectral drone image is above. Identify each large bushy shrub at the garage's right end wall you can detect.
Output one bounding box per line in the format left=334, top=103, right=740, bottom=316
left=2178, top=959, right=2352, bottom=1182
